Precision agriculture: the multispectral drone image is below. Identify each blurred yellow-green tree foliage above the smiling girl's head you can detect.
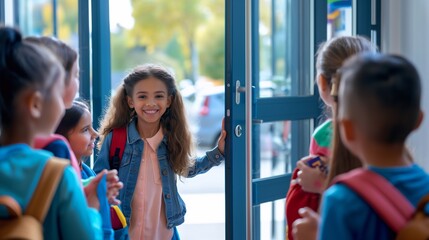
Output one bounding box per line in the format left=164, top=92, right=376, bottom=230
left=130, top=0, right=224, bottom=79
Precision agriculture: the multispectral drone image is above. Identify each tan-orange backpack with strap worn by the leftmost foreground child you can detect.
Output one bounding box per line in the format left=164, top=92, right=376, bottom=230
left=0, top=157, right=69, bottom=240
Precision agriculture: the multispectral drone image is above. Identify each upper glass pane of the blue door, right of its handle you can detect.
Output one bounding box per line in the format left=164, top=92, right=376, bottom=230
left=259, top=0, right=314, bottom=98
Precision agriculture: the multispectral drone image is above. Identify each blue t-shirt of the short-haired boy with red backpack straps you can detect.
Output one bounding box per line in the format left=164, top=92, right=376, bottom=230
left=318, top=164, right=429, bottom=240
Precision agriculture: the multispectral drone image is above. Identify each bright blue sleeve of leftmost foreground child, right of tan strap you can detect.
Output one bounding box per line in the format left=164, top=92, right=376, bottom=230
left=44, top=167, right=103, bottom=239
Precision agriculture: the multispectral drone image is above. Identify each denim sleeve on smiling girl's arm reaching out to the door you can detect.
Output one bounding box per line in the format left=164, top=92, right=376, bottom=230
left=187, top=147, right=225, bottom=177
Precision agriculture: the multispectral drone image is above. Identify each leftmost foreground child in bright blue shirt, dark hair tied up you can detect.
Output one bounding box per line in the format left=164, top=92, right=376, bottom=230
left=0, top=27, right=106, bottom=240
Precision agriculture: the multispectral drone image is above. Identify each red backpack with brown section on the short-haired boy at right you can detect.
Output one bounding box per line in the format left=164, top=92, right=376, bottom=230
left=333, top=168, right=429, bottom=240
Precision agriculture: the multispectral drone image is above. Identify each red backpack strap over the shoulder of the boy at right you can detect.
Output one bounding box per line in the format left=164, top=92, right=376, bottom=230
left=332, top=168, right=414, bottom=232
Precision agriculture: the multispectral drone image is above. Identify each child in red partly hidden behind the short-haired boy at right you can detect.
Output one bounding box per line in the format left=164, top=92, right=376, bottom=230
left=286, top=36, right=377, bottom=240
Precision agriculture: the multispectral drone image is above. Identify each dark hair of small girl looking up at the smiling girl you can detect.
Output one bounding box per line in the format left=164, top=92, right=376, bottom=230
left=55, top=99, right=89, bottom=139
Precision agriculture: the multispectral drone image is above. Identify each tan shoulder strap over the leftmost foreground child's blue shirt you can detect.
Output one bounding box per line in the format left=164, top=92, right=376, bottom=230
left=25, top=157, right=69, bottom=222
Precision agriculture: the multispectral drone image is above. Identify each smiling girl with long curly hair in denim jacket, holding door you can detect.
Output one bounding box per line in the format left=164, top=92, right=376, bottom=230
left=94, top=65, right=226, bottom=240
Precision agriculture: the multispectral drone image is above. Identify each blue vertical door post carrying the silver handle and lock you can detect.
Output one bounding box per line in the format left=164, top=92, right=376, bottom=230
left=225, top=0, right=246, bottom=239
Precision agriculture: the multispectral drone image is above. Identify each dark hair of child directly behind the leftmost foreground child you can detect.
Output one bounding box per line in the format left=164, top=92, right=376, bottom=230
left=25, top=36, right=77, bottom=86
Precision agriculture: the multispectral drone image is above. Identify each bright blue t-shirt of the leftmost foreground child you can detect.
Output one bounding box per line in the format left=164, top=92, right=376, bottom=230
left=0, top=144, right=102, bottom=239
